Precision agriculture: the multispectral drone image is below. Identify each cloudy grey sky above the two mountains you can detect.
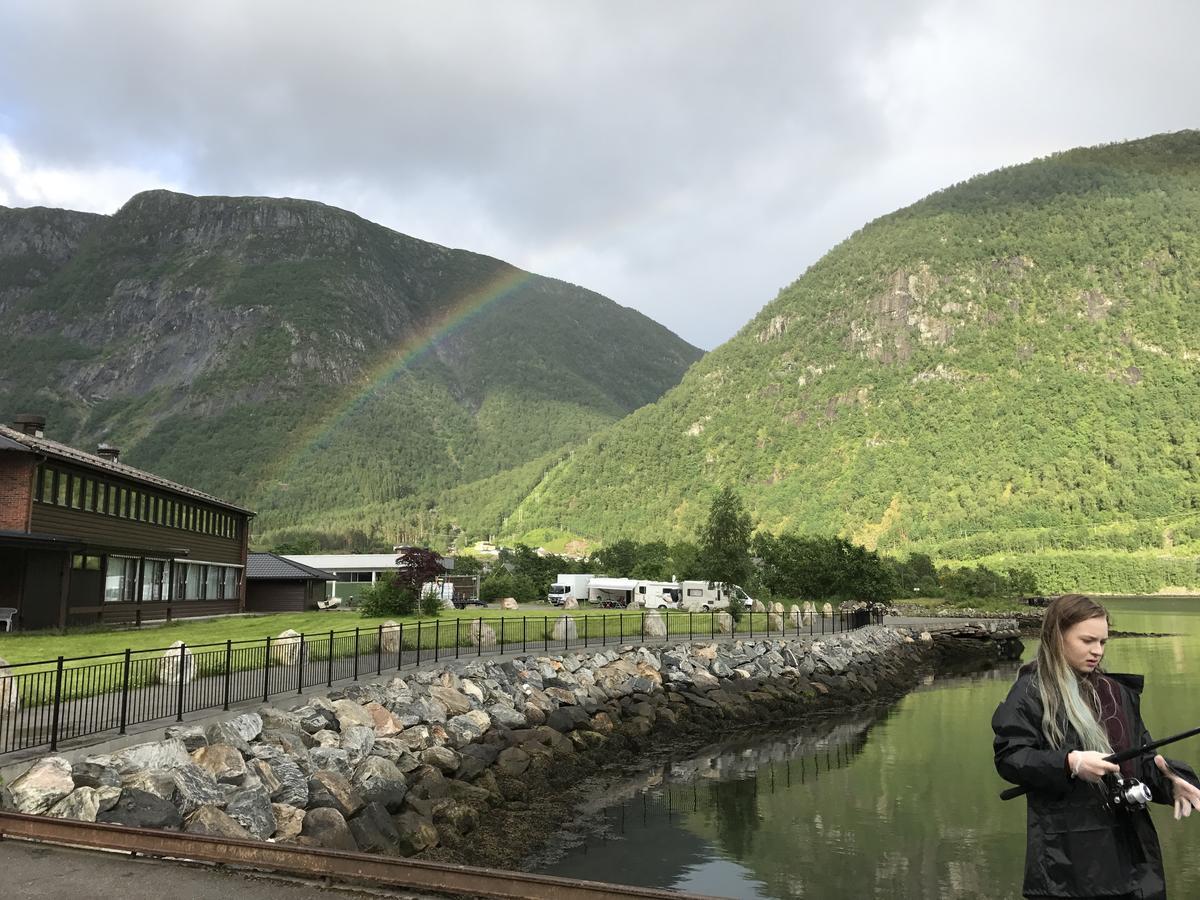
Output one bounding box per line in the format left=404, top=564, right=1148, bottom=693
left=0, top=0, right=1200, bottom=349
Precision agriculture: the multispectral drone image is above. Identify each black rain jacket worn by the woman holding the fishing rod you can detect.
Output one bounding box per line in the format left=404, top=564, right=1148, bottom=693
left=991, top=665, right=1200, bottom=898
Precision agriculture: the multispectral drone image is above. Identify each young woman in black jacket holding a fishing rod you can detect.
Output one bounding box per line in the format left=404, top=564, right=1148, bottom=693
left=991, top=594, right=1200, bottom=898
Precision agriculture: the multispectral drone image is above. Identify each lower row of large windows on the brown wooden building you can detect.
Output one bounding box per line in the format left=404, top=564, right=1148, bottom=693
left=72, top=553, right=241, bottom=604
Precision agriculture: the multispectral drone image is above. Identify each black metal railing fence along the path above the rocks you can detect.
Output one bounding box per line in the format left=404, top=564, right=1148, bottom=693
left=0, top=608, right=882, bottom=755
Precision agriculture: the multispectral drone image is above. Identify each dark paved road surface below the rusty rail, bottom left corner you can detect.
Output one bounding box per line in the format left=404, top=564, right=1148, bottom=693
left=0, top=840, right=446, bottom=900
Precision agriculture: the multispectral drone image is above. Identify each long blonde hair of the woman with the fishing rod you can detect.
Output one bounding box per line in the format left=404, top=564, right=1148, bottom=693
left=1033, top=594, right=1112, bottom=755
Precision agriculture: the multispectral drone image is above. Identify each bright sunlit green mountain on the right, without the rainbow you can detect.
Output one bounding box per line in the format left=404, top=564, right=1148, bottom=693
left=505, top=131, right=1200, bottom=592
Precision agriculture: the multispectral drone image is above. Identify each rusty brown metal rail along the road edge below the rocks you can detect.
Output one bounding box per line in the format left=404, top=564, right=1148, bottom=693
left=0, top=812, right=710, bottom=900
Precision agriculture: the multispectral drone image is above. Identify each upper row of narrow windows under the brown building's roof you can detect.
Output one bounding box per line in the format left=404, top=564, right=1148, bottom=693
left=34, top=464, right=238, bottom=539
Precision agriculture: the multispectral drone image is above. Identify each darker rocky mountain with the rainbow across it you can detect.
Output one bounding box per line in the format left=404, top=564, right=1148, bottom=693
left=0, top=191, right=701, bottom=546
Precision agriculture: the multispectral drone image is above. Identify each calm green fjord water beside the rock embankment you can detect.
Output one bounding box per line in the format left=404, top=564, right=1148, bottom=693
left=542, top=598, right=1200, bottom=900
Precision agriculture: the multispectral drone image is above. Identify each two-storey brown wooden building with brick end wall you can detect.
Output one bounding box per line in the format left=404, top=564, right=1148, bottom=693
left=0, top=416, right=254, bottom=629
